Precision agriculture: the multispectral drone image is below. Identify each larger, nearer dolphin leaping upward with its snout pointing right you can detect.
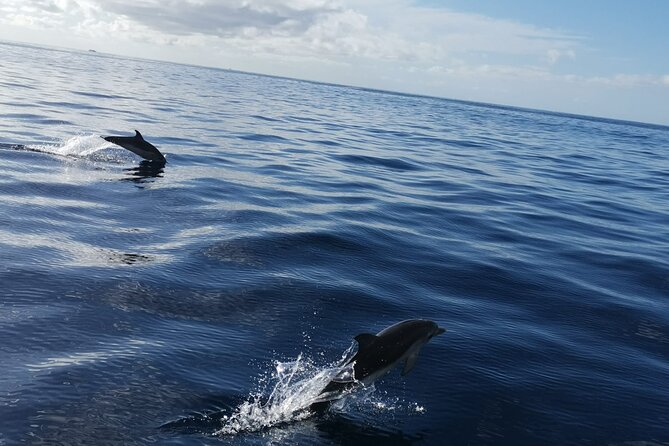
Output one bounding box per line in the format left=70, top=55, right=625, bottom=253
left=309, top=319, right=446, bottom=412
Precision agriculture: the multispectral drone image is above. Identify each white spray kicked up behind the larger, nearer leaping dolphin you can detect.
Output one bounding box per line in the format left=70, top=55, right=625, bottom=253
left=214, top=346, right=355, bottom=435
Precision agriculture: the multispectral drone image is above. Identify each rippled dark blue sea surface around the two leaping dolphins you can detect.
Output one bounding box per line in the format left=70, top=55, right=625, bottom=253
left=0, top=44, right=669, bottom=445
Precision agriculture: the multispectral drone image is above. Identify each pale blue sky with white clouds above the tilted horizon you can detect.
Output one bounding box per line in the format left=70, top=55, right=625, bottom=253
left=0, top=0, right=669, bottom=125
